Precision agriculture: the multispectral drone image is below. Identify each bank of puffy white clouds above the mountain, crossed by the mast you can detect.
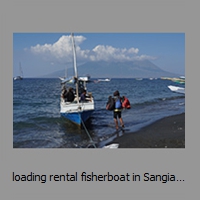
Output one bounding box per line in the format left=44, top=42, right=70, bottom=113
left=30, top=35, right=156, bottom=63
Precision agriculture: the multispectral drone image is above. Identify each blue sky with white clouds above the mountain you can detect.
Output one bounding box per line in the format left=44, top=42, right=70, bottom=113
left=13, top=33, right=185, bottom=77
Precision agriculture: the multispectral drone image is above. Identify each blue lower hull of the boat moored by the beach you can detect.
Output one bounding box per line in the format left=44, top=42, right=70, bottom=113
left=60, top=110, right=93, bottom=125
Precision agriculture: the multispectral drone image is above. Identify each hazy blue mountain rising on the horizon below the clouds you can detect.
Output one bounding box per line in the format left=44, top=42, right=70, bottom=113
left=41, top=60, right=177, bottom=78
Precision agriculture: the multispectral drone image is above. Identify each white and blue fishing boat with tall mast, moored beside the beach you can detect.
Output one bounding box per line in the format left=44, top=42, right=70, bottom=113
left=60, top=34, right=94, bottom=126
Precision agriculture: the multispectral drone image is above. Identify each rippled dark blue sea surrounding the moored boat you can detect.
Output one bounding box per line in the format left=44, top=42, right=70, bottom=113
left=13, top=78, right=185, bottom=148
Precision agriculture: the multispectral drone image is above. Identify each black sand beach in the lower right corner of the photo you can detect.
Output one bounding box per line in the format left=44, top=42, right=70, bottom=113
left=109, top=113, right=185, bottom=148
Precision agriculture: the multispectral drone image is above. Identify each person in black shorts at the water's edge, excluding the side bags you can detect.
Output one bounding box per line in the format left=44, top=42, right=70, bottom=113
left=113, top=90, right=124, bottom=130
